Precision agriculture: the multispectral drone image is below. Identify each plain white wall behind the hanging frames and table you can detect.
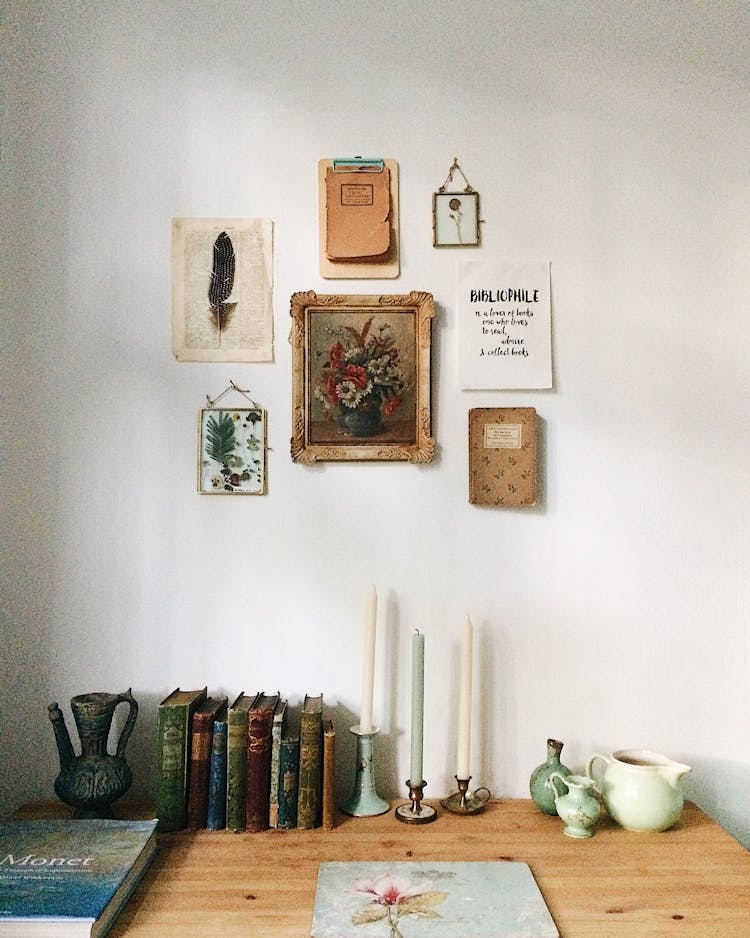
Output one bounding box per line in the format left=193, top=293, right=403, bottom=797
left=0, top=0, right=750, bottom=843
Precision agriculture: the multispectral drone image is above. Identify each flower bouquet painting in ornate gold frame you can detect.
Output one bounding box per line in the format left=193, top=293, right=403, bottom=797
left=290, top=290, right=435, bottom=463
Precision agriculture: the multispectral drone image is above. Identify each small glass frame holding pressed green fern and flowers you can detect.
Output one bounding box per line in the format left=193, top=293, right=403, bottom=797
left=198, top=407, right=266, bottom=495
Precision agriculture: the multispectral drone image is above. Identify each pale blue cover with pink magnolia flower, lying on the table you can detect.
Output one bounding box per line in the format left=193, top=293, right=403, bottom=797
left=311, top=861, right=559, bottom=938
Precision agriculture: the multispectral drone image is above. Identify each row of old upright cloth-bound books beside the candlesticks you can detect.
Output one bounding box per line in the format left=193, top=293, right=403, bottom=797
left=156, top=687, right=335, bottom=832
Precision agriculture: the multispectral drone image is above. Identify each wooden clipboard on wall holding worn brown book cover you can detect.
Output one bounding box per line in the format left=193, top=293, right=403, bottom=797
left=318, top=156, right=400, bottom=280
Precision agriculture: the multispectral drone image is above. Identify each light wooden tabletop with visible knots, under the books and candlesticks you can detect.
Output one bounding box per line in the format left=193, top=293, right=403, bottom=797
left=18, top=800, right=750, bottom=938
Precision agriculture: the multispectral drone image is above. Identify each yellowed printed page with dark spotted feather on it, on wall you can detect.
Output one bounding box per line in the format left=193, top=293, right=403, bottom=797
left=172, top=218, right=273, bottom=362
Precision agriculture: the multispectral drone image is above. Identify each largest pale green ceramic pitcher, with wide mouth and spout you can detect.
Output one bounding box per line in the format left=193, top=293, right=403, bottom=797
left=586, top=749, right=690, bottom=831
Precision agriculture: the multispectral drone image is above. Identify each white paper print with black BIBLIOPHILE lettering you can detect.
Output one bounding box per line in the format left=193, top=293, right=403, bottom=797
left=456, top=261, right=552, bottom=390
